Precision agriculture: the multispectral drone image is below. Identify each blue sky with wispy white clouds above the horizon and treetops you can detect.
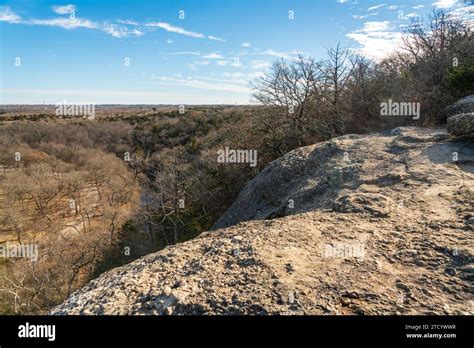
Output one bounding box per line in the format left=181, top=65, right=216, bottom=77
left=0, top=0, right=473, bottom=104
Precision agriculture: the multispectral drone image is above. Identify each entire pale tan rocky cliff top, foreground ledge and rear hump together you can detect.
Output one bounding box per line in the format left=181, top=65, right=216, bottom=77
left=51, top=128, right=474, bottom=315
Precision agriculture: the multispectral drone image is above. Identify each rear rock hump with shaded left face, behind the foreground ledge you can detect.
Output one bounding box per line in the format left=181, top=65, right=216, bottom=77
left=214, top=128, right=473, bottom=228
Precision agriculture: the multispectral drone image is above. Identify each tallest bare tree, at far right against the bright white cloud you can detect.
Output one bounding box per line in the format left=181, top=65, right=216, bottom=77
left=396, top=10, right=474, bottom=124
